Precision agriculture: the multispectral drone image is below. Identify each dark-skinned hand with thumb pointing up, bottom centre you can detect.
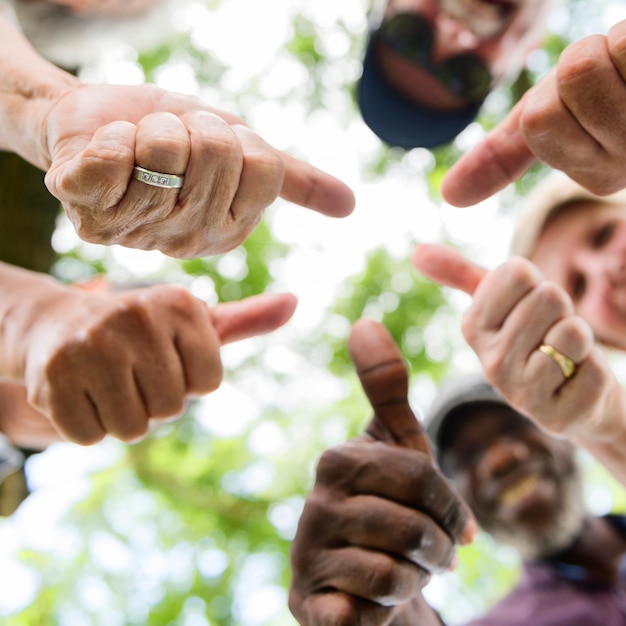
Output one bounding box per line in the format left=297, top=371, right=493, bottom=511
left=289, top=320, right=475, bottom=626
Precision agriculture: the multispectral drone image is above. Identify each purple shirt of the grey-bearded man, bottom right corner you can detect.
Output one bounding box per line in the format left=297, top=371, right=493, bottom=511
left=467, top=516, right=626, bottom=626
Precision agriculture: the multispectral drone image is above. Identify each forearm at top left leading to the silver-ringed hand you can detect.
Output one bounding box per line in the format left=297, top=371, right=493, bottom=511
left=0, top=11, right=81, bottom=171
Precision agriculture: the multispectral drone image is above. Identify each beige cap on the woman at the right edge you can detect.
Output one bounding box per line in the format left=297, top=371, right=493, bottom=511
left=509, top=171, right=626, bottom=258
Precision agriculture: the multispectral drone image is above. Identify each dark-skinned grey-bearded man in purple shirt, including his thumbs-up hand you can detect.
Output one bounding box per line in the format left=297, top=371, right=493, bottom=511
left=290, top=320, right=626, bottom=626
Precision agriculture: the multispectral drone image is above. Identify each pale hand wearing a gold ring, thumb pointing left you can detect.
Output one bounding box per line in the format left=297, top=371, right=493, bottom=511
left=413, top=244, right=624, bottom=440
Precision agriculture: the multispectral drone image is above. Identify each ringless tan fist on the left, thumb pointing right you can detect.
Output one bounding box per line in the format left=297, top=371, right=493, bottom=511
left=24, top=285, right=295, bottom=444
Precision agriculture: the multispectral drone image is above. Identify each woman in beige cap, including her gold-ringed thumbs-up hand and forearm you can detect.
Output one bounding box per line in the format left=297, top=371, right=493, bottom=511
left=413, top=174, right=626, bottom=482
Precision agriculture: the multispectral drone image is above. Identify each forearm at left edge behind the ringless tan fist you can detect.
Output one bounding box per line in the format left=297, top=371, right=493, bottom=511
left=0, top=263, right=70, bottom=381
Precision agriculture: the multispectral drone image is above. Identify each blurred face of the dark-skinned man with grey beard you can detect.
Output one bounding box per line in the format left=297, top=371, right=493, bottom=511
left=444, top=405, right=584, bottom=558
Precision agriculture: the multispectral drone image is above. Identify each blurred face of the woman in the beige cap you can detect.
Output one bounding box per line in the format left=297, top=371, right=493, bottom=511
left=530, top=201, right=626, bottom=350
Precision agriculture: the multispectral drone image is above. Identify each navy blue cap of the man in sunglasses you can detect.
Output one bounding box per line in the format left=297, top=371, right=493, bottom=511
left=357, top=34, right=480, bottom=149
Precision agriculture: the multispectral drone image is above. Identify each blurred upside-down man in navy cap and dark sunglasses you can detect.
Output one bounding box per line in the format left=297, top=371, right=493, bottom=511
left=358, top=0, right=558, bottom=148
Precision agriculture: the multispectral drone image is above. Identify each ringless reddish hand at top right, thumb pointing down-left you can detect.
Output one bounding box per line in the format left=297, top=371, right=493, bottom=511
left=441, top=20, right=626, bottom=206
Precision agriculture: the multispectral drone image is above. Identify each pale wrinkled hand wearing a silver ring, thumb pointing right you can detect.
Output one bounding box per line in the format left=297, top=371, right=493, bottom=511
left=41, top=85, right=354, bottom=257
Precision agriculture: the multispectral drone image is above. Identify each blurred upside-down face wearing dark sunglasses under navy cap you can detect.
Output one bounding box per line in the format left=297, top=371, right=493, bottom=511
left=376, top=0, right=554, bottom=111
